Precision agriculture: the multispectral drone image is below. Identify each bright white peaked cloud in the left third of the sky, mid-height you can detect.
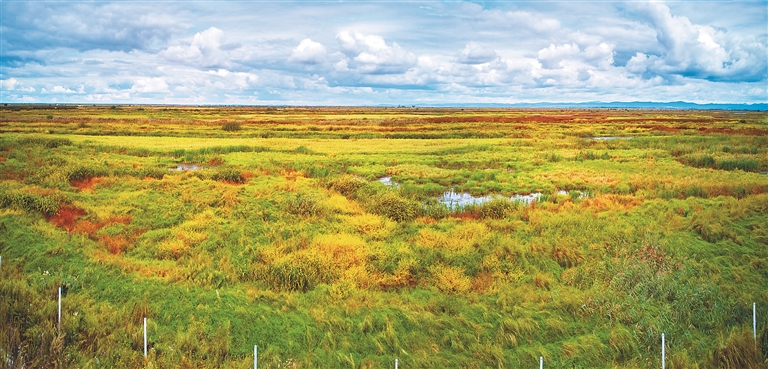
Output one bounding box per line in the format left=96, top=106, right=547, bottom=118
left=160, top=27, right=231, bottom=68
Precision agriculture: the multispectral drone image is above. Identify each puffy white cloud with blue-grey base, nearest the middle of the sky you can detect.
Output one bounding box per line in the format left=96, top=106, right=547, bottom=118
left=336, top=31, right=417, bottom=74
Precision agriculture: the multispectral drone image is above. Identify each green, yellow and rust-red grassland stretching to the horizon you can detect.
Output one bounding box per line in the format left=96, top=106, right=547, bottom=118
left=0, top=105, right=768, bottom=368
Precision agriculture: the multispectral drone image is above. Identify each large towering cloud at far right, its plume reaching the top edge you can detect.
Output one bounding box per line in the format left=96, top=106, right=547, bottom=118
left=627, top=3, right=768, bottom=81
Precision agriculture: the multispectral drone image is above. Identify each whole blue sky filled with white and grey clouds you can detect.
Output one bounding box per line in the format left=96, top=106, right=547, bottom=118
left=0, top=0, right=768, bottom=105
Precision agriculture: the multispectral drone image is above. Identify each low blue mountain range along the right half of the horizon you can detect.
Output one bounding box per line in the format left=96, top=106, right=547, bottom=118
left=390, top=101, right=768, bottom=111
